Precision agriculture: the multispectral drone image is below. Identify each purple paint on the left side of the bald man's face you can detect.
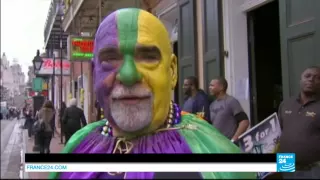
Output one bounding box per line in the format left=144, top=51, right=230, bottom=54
left=93, top=12, right=118, bottom=124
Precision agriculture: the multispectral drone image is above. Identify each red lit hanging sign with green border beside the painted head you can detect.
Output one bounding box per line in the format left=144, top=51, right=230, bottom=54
left=68, top=36, right=94, bottom=61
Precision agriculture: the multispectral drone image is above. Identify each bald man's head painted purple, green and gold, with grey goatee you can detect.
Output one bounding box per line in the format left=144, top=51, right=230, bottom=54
left=93, top=8, right=177, bottom=134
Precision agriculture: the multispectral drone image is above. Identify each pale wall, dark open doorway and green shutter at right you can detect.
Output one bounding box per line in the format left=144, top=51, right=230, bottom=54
left=222, top=0, right=320, bottom=124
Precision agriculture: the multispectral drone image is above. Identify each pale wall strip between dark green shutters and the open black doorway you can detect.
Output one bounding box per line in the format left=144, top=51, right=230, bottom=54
left=222, top=0, right=250, bottom=118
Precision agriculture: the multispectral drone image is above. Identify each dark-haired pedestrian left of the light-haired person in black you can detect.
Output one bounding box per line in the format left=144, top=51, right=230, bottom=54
left=37, top=101, right=55, bottom=154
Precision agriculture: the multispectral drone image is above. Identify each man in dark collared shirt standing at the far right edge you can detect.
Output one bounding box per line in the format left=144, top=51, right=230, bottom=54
left=278, top=66, right=320, bottom=179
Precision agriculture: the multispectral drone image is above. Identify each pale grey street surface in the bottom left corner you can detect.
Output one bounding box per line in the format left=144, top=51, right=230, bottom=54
left=1, top=119, right=23, bottom=179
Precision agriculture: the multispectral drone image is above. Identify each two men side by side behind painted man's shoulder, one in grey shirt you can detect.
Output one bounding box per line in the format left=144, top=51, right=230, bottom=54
left=182, top=76, right=249, bottom=142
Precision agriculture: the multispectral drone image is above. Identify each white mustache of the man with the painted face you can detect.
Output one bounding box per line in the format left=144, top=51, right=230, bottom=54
left=110, top=85, right=152, bottom=99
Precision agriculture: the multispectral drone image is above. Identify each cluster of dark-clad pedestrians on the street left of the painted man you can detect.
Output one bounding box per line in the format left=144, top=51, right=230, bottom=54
left=23, top=98, right=87, bottom=154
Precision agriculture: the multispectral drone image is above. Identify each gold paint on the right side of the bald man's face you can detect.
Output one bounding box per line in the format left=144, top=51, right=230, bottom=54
left=135, top=11, right=177, bottom=132
